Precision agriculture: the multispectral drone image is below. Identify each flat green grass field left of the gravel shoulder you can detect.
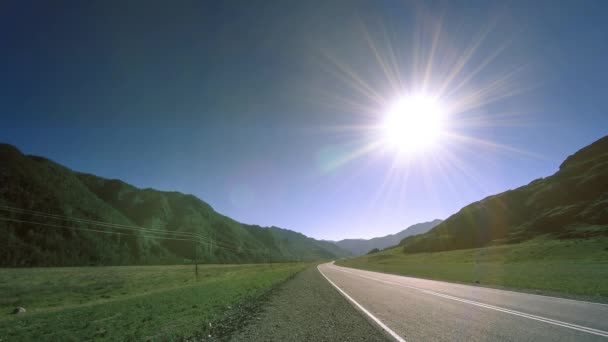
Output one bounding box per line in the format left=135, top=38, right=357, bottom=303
left=0, top=264, right=308, bottom=341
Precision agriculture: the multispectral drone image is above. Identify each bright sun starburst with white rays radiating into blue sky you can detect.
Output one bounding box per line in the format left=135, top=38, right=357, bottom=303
left=319, top=8, right=530, bottom=179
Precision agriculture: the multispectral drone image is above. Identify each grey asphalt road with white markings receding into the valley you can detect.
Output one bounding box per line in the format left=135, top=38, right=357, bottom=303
left=318, top=263, right=608, bottom=341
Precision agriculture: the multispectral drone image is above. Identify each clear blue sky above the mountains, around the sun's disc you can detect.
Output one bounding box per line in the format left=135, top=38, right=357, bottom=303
left=0, top=0, right=608, bottom=239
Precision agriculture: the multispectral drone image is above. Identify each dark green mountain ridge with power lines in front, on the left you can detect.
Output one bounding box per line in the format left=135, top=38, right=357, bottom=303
left=0, top=144, right=349, bottom=266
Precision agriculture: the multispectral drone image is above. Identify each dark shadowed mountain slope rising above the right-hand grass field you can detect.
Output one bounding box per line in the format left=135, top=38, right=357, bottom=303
left=400, top=136, right=608, bottom=253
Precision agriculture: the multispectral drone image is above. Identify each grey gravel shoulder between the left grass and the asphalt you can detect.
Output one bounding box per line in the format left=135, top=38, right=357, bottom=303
left=231, top=267, right=387, bottom=341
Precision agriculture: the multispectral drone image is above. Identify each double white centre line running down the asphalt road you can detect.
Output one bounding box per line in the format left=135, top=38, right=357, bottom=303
left=328, top=266, right=608, bottom=337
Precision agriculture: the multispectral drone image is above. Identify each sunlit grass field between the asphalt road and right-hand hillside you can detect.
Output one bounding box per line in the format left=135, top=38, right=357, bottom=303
left=336, top=238, right=608, bottom=302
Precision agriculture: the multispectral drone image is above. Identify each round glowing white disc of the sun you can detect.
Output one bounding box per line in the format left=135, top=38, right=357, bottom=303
left=382, top=94, right=445, bottom=154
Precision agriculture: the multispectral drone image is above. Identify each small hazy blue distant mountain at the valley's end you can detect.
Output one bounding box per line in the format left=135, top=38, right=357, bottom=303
left=334, top=220, right=441, bottom=256
